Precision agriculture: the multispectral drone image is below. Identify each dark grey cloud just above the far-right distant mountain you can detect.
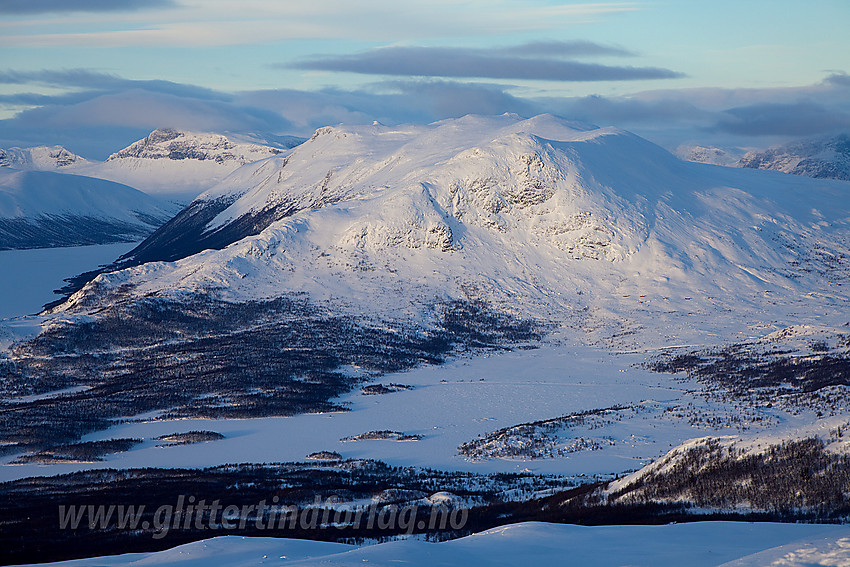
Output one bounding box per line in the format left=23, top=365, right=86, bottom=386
left=715, top=101, right=850, bottom=136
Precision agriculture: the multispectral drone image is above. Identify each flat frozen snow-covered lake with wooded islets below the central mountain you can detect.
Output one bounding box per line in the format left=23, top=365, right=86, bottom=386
left=0, top=338, right=814, bottom=481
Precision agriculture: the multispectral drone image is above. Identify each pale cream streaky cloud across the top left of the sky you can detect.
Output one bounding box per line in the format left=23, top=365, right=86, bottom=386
left=0, top=0, right=641, bottom=49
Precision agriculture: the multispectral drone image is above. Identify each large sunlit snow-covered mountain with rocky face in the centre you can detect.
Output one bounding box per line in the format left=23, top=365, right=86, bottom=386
left=66, top=115, right=850, bottom=340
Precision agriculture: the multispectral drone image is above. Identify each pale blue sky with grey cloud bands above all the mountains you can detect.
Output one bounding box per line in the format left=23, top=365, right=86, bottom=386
left=0, top=0, right=850, bottom=159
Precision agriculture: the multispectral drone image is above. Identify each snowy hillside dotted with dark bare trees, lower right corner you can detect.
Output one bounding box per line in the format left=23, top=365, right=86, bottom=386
left=604, top=412, right=850, bottom=518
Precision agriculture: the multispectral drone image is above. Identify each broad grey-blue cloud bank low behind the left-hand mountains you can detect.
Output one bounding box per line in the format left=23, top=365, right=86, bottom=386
left=0, top=77, right=532, bottom=159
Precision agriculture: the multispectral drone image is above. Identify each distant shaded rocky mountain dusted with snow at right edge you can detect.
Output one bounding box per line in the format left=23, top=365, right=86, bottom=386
left=738, top=134, right=850, bottom=181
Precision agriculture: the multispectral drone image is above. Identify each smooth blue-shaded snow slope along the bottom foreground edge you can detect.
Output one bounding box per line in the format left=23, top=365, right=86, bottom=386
left=18, top=522, right=850, bottom=567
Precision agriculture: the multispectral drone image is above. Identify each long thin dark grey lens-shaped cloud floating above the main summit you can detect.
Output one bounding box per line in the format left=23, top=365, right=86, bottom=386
left=286, top=43, right=684, bottom=81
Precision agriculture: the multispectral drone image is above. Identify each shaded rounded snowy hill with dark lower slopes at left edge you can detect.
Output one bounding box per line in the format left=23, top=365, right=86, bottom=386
left=0, top=168, right=175, bottom=250
